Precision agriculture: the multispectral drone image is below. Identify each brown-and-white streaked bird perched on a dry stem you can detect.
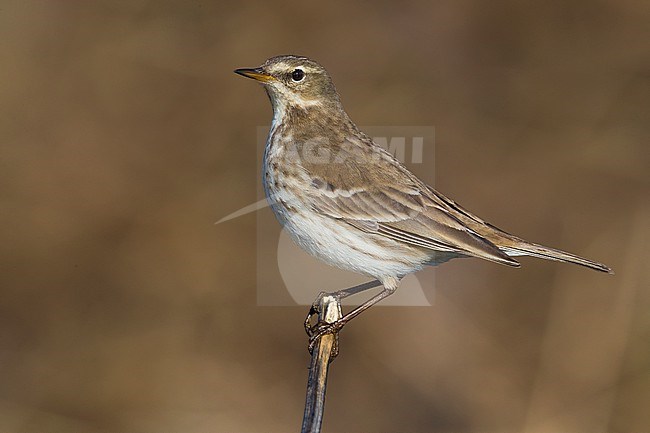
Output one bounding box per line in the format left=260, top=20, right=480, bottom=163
left=234, top=55, right=613, bottom=337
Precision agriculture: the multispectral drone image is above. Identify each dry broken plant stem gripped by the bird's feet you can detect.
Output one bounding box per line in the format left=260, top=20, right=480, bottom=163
left=301, top=294, right=343, bottom=433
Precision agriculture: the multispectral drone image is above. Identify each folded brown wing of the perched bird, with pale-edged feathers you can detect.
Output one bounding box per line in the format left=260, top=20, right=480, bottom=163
left=302, top=135, right=519, bottom=266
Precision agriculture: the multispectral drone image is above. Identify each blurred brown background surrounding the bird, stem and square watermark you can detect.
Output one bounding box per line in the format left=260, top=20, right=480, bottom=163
left=0, top=0, right=650, bottom=433
